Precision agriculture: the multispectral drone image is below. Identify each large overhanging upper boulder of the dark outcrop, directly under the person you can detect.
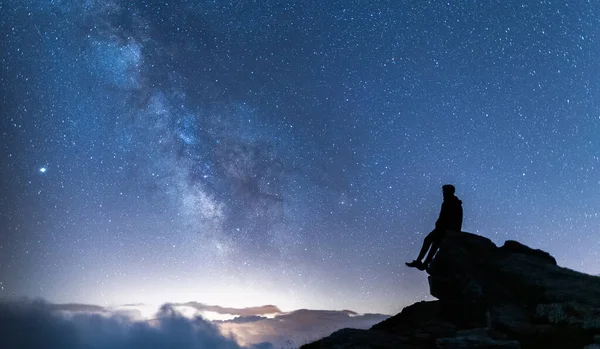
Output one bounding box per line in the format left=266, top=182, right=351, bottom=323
left=428, top=233, right=600, bottom=307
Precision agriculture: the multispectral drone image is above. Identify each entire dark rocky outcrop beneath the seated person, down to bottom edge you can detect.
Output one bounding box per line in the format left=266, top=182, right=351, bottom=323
left=301, top=232, right=600, bottom=349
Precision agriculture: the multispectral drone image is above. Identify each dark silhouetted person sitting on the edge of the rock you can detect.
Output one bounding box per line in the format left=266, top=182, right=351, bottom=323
left=406, top=184, right=463, bottom=270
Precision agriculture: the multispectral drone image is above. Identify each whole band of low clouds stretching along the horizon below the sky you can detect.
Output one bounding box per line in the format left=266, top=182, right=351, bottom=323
left=0, top=301, right=388, bottom=349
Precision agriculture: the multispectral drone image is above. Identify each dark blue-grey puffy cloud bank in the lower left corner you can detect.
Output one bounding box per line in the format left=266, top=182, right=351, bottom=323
left=0, top=301, right=271, bottom=349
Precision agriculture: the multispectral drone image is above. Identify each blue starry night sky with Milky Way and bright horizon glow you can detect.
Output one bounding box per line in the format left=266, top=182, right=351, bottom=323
left=0, top=0, right=600, bottom=314
